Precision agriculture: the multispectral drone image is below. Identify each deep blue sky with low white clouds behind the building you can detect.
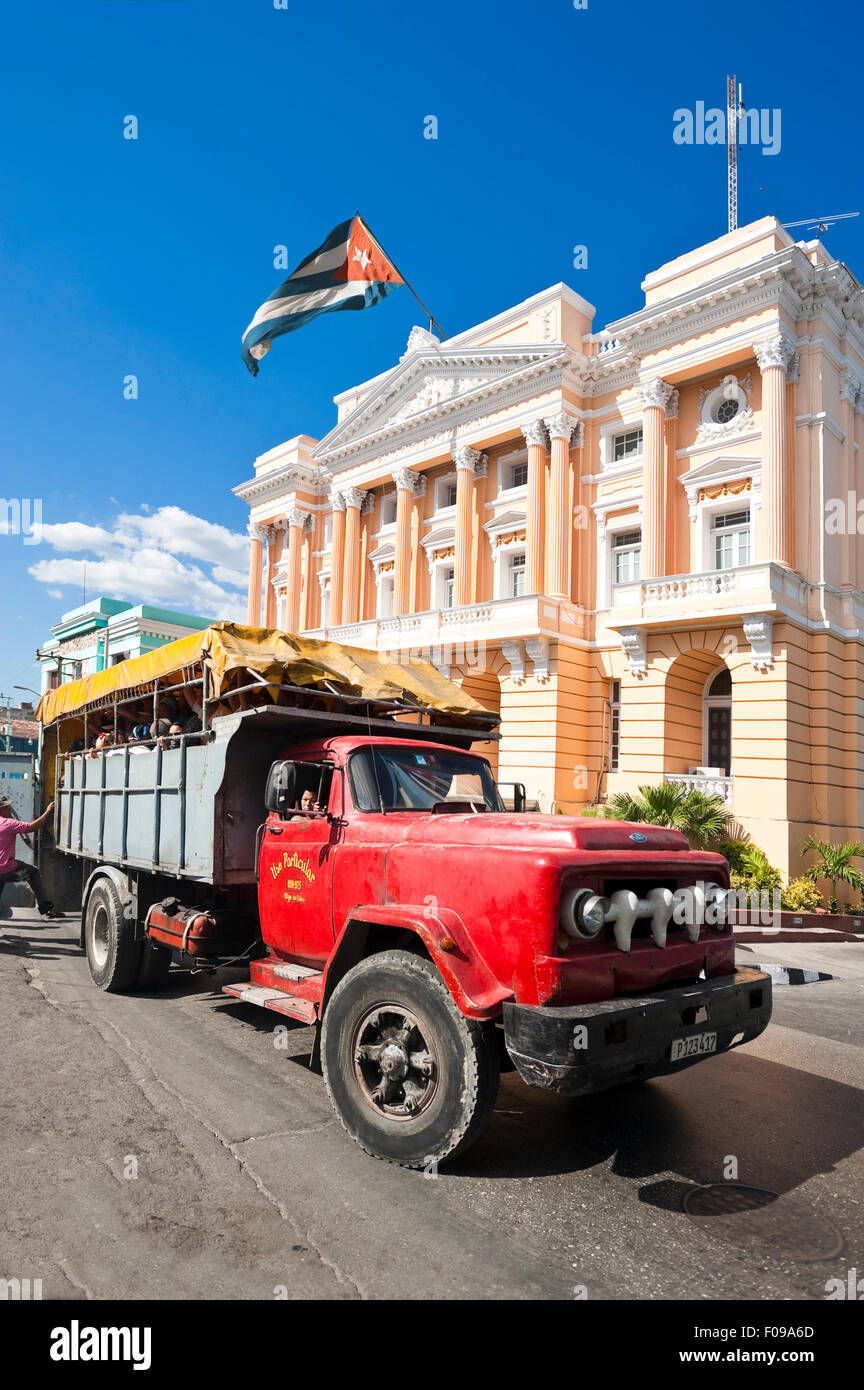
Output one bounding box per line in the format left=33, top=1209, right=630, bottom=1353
left=0, top=0, right=864, bottom=694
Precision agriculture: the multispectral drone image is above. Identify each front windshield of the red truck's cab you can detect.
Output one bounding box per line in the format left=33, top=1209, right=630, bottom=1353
left=349, top=748, right=504, bottom=810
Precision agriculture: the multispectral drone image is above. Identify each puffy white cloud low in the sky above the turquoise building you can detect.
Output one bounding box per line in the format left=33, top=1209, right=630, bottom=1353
left=29, top=506, right=249, bottom=620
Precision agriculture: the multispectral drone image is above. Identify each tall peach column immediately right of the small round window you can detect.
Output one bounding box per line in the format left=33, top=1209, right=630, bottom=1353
left=753, top=332, right=795, bottom=567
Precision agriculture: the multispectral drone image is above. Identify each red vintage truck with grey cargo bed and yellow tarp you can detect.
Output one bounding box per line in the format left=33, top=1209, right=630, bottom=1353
left=40, top=624, right=771, bottom=1168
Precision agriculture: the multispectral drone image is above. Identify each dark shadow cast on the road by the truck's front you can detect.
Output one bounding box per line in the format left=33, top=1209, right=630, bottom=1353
left=447, top=1049, right=864, bottom=1211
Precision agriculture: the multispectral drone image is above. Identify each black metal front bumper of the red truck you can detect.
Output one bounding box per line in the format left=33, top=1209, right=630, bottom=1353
left=503, top=969, right=771, bottom=1095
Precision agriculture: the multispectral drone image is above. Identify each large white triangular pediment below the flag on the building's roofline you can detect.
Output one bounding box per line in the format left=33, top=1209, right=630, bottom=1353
left=314, top=335, right=570, bottom=463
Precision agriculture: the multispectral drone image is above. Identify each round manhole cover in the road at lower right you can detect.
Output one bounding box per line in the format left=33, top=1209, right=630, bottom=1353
left=682, top=1183, right=843, bottom=1259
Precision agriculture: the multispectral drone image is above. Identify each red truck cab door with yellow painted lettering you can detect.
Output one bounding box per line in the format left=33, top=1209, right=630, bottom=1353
left=258, top=763, right=340, bottom=966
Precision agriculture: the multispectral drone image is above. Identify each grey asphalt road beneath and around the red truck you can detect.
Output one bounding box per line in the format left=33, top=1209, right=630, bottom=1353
left=0, top=909, right=864, bottom=1301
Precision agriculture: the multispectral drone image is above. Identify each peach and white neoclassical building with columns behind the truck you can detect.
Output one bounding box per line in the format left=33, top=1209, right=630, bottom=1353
left=235, top=218, right=864, bottom=872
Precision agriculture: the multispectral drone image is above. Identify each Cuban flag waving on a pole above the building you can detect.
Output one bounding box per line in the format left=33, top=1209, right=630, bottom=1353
left=243, top=215, right=404, bottom=377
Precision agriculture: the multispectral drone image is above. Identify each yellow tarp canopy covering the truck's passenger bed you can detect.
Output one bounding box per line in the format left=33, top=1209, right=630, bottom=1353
left=36, top=623, right=497, bottom=728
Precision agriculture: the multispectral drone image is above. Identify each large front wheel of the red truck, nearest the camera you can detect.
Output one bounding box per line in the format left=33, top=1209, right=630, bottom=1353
left=321, top=951, right=500, bottom=1168
